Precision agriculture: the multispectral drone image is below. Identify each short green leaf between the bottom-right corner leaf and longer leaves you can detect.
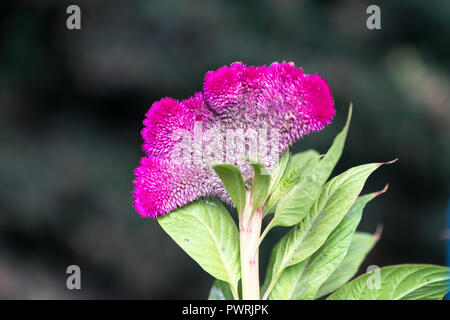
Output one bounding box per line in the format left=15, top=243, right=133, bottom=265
left=316, top=232, right=377, bottom=298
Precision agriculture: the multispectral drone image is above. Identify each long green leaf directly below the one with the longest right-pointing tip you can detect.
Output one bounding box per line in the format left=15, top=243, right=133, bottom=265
left=270, top=192, right=380, bottom=300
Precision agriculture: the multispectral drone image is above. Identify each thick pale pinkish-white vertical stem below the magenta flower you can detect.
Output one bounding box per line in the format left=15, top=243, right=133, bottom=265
left=239, top=191, right=262, bottom=300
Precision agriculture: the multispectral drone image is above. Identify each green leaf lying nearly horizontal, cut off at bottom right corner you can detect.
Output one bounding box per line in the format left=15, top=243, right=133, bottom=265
left=327, top=264, right=450, bottom=300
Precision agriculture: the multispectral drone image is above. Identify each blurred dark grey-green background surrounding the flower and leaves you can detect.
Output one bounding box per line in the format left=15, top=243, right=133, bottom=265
left=0, top=0, right=450, bottom=299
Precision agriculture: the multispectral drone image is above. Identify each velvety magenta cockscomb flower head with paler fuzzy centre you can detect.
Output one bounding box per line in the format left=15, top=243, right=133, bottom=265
left=133, top=62, right=335, bottom=218
